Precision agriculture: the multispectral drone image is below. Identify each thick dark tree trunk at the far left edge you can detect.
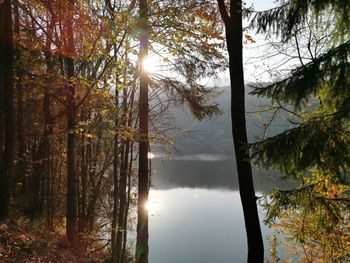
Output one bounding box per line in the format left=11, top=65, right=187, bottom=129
left=0, top=0, right=15, bottom=220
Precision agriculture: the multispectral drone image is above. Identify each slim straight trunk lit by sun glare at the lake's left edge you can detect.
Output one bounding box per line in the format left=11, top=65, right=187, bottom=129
left=136, top=0, right=149, bottom=263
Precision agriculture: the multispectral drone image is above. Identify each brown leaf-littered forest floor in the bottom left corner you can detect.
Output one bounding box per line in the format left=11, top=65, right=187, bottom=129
left=0, top=220, right=104, bottom=263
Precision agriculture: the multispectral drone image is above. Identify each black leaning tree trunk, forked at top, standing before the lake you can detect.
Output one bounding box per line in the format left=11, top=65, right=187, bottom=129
left=218, top=0, right=264, bottom=262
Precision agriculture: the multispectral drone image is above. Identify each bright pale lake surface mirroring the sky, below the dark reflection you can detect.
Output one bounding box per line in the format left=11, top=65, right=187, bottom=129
left=149, top=188, right=269, bottom=263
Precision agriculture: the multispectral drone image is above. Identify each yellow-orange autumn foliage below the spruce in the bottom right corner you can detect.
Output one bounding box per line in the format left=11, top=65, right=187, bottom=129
left=263, top=174, right=350, bottom=262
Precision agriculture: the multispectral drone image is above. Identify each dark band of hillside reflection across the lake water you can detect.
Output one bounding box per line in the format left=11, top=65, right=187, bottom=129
left=152, top=156, right=295, bottom=192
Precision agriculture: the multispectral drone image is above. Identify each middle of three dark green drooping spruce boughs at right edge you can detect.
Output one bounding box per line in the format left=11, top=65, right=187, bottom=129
left=252, top=41, right=350, bottom=109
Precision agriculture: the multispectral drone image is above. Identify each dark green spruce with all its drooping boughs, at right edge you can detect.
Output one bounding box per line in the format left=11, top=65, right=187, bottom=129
left=251, top=1, right=350, bottom=196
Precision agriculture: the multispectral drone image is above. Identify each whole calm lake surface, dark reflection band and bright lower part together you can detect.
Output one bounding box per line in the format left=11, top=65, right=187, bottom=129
left=148, top=160, right=287, bottom=263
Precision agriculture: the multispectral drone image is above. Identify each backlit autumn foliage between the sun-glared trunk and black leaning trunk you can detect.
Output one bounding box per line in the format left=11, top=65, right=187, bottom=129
left=144, top=1, right=227, bottom=120
